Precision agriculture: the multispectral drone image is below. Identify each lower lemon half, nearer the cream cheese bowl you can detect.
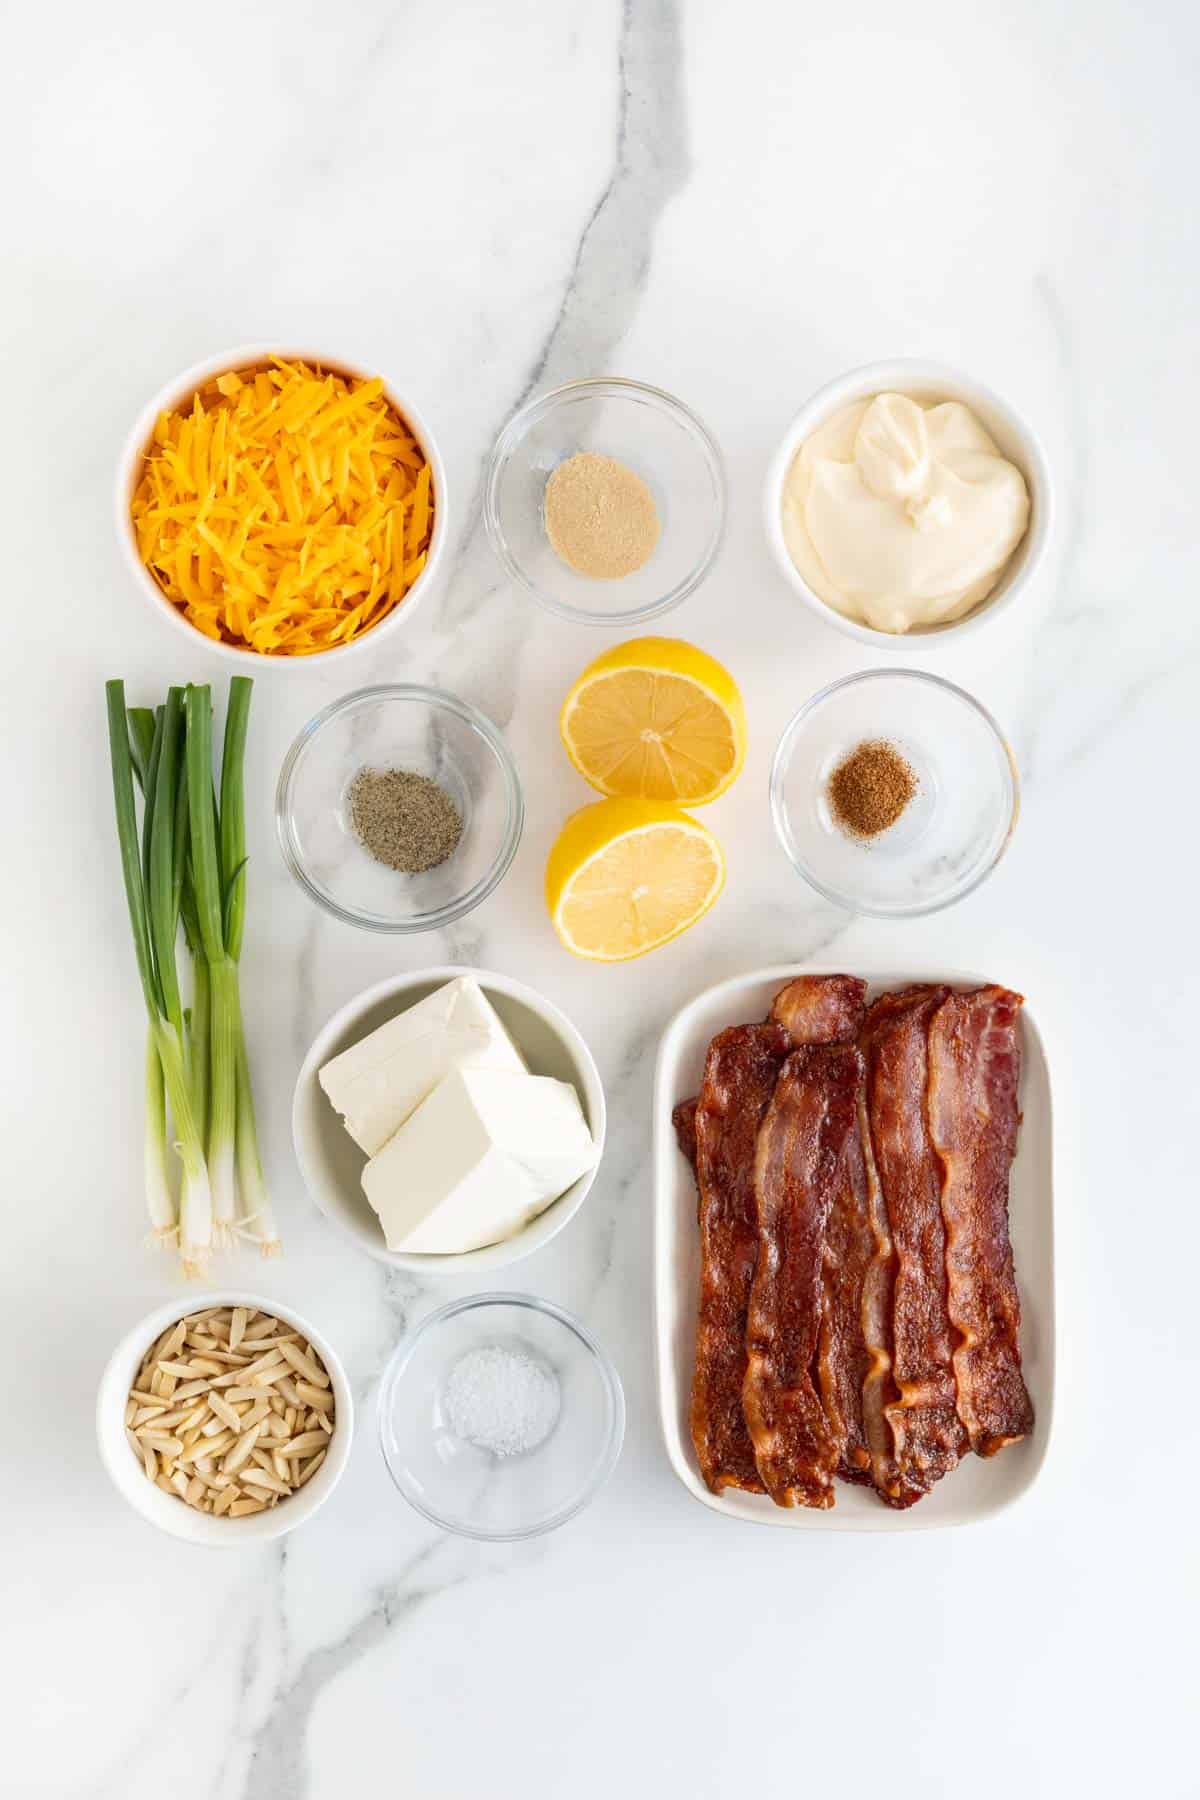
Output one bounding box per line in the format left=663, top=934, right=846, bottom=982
left=545, top=799, right=725, bottom=963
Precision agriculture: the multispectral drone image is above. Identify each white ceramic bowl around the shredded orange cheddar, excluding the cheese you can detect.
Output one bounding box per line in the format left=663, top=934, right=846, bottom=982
left=115, top=344, right=450, bottom=670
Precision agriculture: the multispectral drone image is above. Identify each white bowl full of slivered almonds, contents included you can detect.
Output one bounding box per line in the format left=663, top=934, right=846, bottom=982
left=95, top=1292, right=354, bottom=1548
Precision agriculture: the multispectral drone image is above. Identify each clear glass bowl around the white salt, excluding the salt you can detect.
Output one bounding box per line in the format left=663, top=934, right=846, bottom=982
left=380, top=1294, right=624, bottom=1543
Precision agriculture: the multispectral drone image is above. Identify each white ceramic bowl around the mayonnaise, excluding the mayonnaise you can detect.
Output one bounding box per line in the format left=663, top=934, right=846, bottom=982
left=765, top=358, right=1054, bottom=653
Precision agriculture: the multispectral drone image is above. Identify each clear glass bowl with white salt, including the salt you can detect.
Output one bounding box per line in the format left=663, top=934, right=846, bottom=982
left=380, top=1294, right=624, bottom=1543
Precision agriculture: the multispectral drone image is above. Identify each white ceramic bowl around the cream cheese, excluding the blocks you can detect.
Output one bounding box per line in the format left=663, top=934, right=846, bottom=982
left=291, top=963, right=604, bottom=1274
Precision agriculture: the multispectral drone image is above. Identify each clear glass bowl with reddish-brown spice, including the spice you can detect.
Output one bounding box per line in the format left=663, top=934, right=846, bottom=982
left=770, top=670, right=1018, bottom=918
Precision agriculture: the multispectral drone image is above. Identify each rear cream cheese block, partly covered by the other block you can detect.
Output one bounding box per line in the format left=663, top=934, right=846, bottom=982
left=318, top=976, right=525, bottom=1156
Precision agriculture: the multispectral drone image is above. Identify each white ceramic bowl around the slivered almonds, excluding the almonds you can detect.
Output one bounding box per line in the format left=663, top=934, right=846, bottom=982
left=95, top=1289, right=354, bottom=1550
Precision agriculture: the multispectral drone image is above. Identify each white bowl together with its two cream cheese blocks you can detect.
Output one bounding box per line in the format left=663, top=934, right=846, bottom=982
left=291, top=965, right=604, bottom=1274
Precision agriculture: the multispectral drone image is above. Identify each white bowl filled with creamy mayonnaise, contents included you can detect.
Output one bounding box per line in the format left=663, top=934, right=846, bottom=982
left=765, top=358, right=1054, bottom=650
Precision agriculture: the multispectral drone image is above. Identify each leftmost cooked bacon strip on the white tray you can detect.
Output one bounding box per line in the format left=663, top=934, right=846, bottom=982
left=691, top=1022, right=790, bottom=1494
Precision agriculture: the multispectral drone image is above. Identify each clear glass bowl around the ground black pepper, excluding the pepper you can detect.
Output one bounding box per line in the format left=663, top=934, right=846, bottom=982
left=284, top=686, right=525, bottom=932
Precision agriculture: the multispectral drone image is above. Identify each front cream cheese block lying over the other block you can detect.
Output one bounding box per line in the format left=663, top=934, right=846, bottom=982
left=362, top=1067, right=596, bottom=1256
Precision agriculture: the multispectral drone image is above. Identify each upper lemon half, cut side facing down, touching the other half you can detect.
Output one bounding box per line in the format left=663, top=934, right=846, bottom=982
left=558, top=637, right=747, bottom=806
